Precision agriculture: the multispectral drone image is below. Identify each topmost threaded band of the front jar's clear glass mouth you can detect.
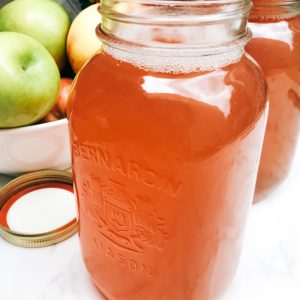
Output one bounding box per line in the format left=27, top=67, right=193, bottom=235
left=98, top=0, right=252, bottom=26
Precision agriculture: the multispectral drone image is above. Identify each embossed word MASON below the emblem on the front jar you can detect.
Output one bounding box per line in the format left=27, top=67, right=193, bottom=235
left=93, top=238, right=153, bottom=278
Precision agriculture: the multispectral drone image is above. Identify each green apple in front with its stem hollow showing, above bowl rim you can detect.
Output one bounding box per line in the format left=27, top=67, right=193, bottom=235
left=0, top=32, right=60, bottom=128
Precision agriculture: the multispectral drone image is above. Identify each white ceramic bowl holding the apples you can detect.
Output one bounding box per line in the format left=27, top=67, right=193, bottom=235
left=0, top=119, right=71, bottom=175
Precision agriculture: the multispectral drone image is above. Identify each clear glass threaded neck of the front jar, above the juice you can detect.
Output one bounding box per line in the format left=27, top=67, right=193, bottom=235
left=97, top=0, right=251, bottom=69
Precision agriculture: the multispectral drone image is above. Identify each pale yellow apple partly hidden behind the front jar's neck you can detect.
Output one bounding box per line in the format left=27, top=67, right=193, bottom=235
left=67, top=4, right=101, bottom=73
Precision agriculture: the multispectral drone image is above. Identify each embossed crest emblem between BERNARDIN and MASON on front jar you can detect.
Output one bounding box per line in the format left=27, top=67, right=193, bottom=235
left=81, top=175, right=168, bottom=253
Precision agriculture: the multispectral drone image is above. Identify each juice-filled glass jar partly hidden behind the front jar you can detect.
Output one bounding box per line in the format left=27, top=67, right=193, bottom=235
left=246, top=0, right=300, bottom=201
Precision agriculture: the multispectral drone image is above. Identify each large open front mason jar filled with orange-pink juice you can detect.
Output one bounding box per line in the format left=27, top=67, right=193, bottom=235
left=69, top=0, right=267, bottom=300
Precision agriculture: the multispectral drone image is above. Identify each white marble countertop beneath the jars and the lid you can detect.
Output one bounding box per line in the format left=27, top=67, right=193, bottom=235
left=0, top=147, right=300, bottom=300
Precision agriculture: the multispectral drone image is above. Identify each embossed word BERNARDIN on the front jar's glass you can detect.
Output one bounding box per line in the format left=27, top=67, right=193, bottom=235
left=73, top=142, right=182, bottom=197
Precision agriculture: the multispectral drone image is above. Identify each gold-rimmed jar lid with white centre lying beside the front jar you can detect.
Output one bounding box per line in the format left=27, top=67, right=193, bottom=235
left=0, top=170, right=77, bottom=248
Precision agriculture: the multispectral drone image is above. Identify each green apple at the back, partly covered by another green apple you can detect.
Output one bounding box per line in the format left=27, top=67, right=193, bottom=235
left=0, top=0, right=70, bottom=70
